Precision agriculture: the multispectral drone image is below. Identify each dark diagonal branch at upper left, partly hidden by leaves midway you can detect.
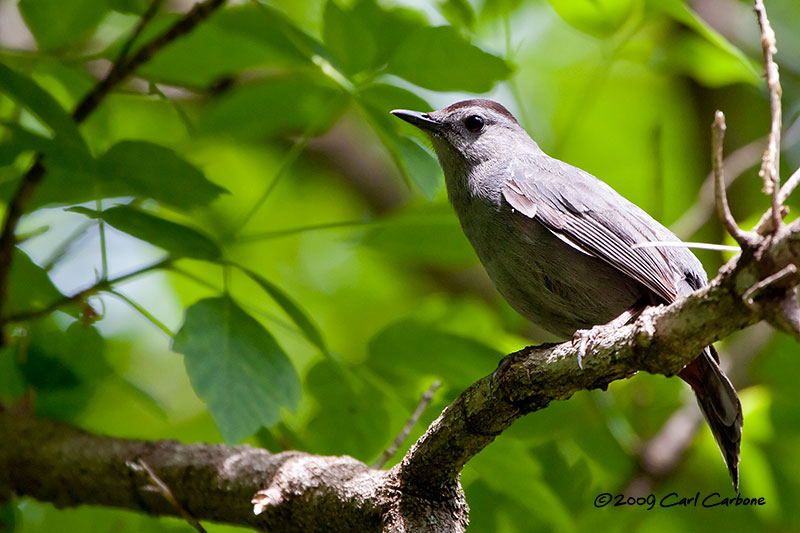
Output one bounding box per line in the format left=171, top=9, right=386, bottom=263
left=0, top=0, right=225, bottom=334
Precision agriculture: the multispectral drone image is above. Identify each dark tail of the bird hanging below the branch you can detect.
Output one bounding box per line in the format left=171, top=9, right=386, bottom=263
left=678, top=346, right=742, bottom=492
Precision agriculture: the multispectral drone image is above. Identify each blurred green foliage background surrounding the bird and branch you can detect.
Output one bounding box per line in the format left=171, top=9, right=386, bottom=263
left=0, top=0, right=800, bottom=532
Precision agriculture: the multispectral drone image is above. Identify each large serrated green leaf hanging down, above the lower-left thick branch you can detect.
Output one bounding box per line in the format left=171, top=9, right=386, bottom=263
left=172, top=297, right=300, bottom=444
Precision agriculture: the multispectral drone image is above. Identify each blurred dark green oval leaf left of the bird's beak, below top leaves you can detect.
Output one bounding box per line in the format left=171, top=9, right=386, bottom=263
left=198, top=74, right=346, bottom=139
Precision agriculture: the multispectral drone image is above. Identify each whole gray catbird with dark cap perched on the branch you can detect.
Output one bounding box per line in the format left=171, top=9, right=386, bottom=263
left=392, top=100, right=742, bottom=491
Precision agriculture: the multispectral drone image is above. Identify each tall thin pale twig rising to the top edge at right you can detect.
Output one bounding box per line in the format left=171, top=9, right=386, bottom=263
left=755, top=0, right=783, bottom=231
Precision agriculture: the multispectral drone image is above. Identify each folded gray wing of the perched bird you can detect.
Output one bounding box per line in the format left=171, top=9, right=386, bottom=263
left=503, top=155, right=705, bottom=302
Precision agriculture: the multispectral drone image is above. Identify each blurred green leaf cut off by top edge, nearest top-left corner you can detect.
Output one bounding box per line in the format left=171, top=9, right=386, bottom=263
left=19, top=0, right=108, bottom=50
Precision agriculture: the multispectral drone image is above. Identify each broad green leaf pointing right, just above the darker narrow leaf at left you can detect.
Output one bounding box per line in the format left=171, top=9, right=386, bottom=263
left=97, top=141, right=226, bottom=209
